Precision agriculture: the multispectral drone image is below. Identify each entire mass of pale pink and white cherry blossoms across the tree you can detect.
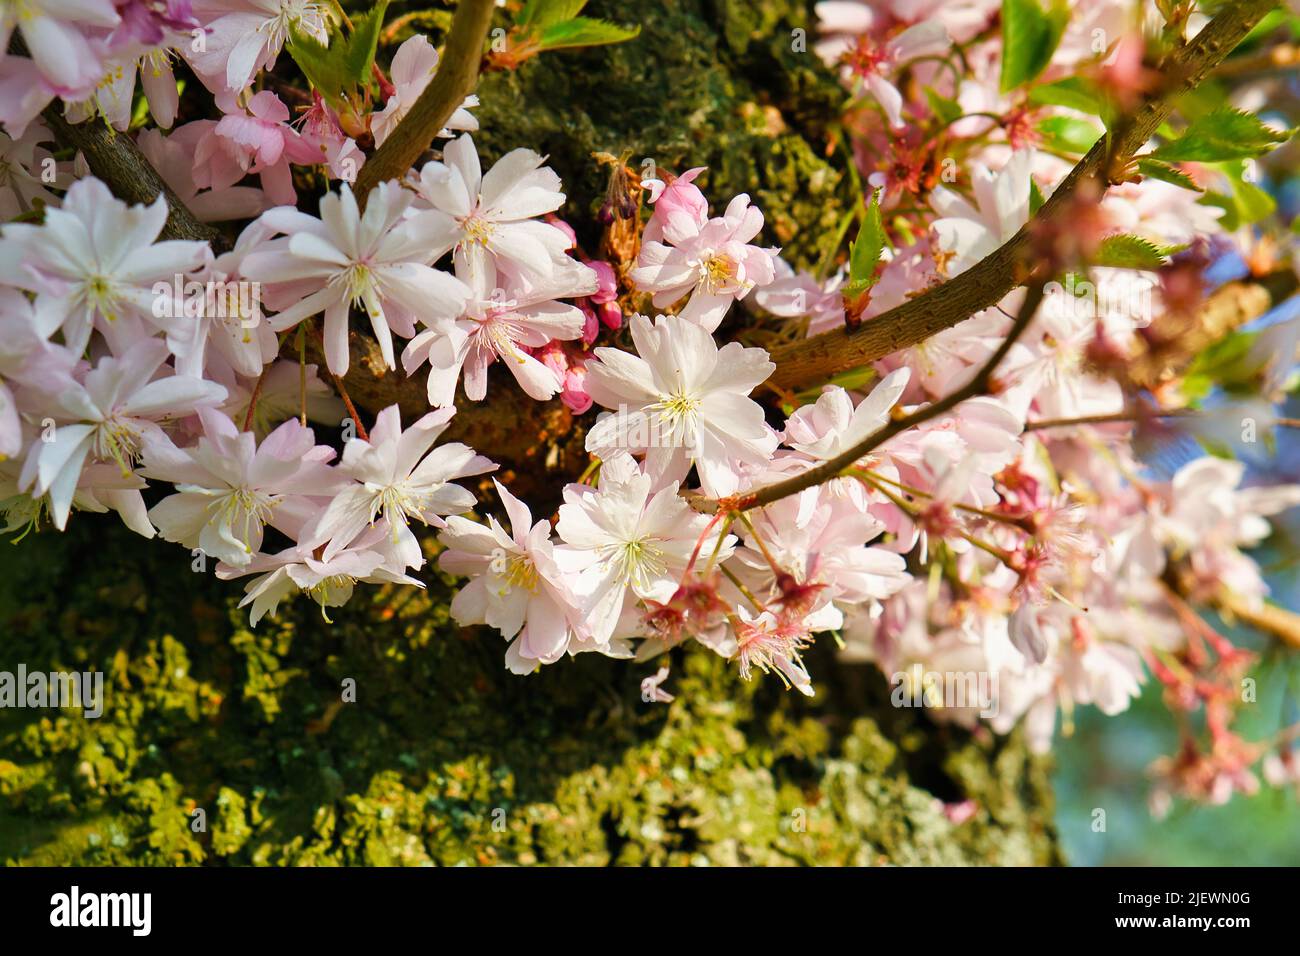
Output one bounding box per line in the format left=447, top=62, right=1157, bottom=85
left=0, top=0, right=1300, bottom=816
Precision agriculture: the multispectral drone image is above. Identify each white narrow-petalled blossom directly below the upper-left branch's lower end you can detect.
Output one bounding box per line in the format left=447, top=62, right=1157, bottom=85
left=242, top=182, right=469, bottom=375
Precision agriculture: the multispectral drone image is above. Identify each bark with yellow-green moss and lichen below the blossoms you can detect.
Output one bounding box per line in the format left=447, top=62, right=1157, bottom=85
left=0, top=515, right=1056, bottom=865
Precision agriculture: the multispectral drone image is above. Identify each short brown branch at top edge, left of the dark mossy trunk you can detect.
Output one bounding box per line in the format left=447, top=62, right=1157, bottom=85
left=354, top=0, right=495, bottom=207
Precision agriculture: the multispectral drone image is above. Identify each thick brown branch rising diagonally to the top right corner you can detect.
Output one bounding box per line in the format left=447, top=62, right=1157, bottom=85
left=768, top=0, right=1277, bottom=390
